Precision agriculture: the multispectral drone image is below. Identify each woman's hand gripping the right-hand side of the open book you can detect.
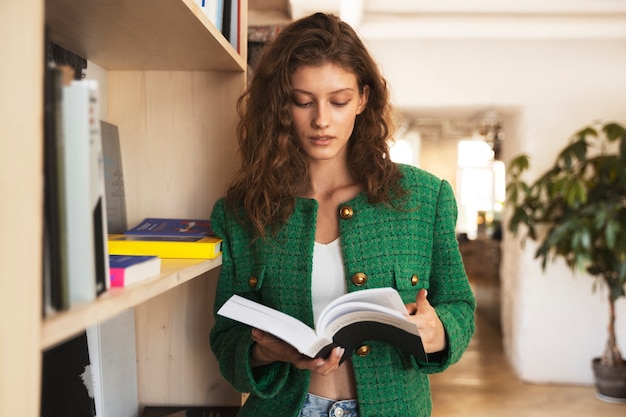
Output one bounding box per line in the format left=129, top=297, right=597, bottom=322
left=406, top=289, right=446, bottom=353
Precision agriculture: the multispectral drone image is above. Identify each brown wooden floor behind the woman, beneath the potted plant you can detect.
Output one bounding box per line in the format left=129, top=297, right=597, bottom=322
left=431, top=242, right=626, bottom=417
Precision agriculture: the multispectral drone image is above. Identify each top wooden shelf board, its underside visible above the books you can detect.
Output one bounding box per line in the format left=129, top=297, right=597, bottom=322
left=46, top=0, right=246, bottom=72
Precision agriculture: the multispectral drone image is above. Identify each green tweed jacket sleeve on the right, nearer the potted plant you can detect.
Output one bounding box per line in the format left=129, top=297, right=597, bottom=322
left=418, top=180, right=476, bottom=373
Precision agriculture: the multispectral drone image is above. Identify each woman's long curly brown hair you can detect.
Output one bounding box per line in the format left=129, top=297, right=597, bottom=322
left=226, top=13, right=402, bottom=237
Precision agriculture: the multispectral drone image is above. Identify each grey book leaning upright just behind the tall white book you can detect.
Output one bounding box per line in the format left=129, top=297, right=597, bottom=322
left=100, top=120, right=128, bottom=233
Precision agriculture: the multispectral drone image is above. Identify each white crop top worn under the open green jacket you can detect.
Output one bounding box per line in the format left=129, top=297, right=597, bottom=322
left=311, top=238, right=348, bottom=321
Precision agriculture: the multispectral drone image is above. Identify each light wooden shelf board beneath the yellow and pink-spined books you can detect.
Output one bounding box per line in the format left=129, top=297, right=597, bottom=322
left=41, top=256, right=222, bottom=349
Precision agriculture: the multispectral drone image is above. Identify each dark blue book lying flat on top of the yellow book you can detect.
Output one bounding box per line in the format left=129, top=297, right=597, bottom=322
left=124, top=217, right=215, bottom=237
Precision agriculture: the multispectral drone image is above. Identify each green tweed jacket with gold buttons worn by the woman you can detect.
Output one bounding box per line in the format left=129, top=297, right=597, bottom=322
left=210, top=165, right=476, bottom=417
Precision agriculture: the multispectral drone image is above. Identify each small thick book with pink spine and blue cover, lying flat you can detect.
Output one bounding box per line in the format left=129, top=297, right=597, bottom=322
left=109, top=255, right=161, bottom=287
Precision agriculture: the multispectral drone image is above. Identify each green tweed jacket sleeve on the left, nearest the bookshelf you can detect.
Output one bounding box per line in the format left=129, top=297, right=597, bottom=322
left=210, top=200, right=289, bottom=398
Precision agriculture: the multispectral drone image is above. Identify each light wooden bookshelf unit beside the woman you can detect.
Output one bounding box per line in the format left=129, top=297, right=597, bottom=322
left=0, top=0, right=247, bottom=417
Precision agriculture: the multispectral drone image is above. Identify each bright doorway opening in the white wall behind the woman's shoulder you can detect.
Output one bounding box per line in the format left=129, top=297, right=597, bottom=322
left=391, top=107, right=519, bottom=328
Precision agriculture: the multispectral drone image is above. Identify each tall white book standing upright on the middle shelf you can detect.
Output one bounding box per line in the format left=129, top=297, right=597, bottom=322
left=60, top=80, right=108, bottom=306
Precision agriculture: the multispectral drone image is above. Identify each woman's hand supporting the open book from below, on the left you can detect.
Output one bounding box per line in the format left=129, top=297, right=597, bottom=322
left=250, top=329, right=344, bottom=375
